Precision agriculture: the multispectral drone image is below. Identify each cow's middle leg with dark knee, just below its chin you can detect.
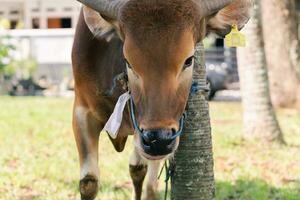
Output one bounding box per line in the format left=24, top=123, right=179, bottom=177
left=129, top=149, right=147, bottom=200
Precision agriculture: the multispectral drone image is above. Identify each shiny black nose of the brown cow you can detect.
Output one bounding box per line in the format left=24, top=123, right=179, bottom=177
left=141, top=129, right=176, bottom=156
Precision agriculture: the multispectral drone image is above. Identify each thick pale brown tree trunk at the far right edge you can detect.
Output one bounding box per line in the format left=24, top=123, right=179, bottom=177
left=262, top=0, right=300, bottom=107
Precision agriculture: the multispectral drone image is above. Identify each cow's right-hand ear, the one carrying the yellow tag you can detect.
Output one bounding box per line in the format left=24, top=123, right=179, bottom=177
left=207, top=0, right=253, bottom=37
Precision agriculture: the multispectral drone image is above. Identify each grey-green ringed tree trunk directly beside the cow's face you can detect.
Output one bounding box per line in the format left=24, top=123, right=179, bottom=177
left=171, top=44, right=215, bottom=200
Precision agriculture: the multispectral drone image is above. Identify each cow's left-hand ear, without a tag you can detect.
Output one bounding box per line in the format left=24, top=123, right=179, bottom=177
left=83, top=6, right=121, bottom=41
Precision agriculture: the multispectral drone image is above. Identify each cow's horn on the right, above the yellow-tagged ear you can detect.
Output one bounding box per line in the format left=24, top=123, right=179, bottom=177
left=194, top=0, right=234, bottom=16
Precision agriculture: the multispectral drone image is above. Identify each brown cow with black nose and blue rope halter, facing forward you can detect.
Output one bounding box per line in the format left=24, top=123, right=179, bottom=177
left=72, top=0, right=252, bottom=199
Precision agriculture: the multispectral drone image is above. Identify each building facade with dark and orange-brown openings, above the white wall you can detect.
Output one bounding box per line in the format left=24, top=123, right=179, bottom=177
left=0, top=0, right=81, bottom=29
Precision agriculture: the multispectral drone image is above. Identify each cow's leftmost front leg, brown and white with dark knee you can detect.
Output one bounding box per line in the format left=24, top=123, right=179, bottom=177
left=73, top=105, right=102, bottom=200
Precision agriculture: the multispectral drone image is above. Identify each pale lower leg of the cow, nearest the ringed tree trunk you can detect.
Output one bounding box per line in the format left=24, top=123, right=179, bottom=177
left=144, top=160, right=161, bottom=200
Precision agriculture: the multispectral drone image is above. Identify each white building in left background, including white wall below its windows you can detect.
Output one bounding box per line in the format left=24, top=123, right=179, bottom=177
left=0, top=0, right=81, bottom=89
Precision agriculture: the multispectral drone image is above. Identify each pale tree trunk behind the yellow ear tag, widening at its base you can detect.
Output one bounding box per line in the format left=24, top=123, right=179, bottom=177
left=238, top=0, right=284, bottom=143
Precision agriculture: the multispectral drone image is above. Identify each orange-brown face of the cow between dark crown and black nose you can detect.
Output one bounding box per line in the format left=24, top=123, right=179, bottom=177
left=124, top=29, right=195, bottom=130
